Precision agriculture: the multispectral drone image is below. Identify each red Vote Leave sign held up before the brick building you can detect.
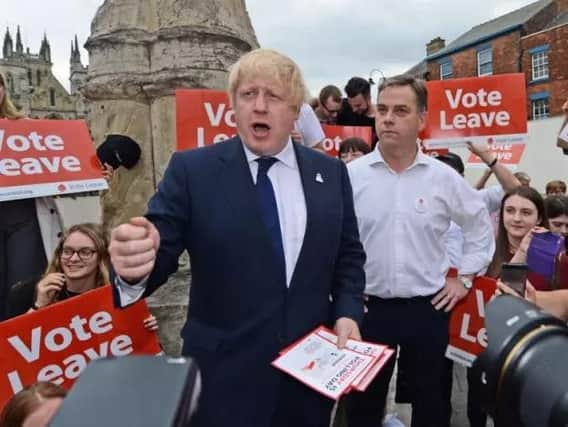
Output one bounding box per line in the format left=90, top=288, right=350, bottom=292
left=421, top=73, right=528, bottom=148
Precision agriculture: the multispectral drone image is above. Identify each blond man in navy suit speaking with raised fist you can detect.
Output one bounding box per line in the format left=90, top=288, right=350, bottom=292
left=110, top=49, right=365, bottom=427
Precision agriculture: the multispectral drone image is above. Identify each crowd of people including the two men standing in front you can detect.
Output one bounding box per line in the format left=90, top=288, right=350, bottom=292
left=0, top=49, right=568, bottom=427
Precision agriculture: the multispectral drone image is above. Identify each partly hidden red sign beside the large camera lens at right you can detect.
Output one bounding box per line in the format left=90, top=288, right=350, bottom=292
left=446, top=277, right=497, bottom=367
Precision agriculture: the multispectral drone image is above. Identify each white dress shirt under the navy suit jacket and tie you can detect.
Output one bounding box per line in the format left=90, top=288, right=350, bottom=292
left=116, top=139, right=307, bottom=306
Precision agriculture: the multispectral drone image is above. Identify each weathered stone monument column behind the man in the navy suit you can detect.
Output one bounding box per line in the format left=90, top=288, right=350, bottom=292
left=82, top=0, right=258, bottom=353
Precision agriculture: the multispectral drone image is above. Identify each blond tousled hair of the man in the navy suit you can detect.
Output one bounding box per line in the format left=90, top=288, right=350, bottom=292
left=228, top=49, right=307, bottom=112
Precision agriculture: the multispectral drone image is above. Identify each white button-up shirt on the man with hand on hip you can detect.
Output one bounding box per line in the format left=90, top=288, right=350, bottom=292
left=348, top=144, right=495, bottom=298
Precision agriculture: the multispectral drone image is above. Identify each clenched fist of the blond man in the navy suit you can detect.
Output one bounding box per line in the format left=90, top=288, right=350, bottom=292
left=109, top=217, right=160, bottom=283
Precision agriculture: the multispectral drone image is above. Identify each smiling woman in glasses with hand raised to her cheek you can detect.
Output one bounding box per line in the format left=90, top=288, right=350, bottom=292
left=8, top=223, right=158, bottom=330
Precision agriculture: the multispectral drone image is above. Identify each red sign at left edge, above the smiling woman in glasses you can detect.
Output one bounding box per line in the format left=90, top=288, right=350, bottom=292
left=0, top=119, right=108, bottom=202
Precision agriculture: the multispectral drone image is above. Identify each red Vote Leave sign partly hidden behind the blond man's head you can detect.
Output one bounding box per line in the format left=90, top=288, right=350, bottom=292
left=176, top=89, right=372, bottom=157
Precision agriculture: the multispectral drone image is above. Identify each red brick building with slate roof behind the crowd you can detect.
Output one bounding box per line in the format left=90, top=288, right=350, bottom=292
left=408, top=0, right=568, bottom=120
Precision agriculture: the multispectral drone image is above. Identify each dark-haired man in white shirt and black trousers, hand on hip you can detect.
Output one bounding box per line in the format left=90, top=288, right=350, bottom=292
left=348, top=76, right=495, bottom=427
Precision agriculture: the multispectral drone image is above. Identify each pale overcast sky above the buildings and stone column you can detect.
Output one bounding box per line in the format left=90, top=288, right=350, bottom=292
left=0, top=0, right=532, bottom=95
